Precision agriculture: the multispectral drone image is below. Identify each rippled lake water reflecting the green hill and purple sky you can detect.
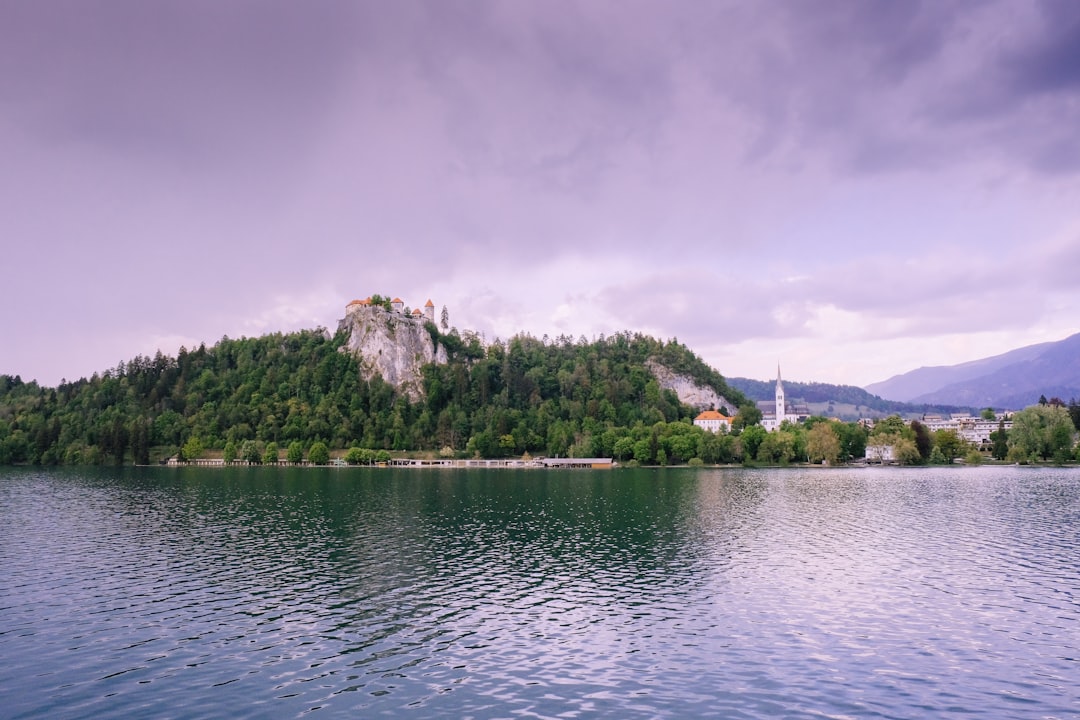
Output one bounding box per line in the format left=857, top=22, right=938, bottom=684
left=0, top=467, right=1080, bottom=718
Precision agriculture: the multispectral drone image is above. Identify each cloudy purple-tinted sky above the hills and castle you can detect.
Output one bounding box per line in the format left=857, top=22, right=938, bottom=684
left=0, top=0, right=1080, bottom=385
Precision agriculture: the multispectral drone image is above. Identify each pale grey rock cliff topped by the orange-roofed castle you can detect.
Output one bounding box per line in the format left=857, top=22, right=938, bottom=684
left=338, top=307, right=446, bottom=400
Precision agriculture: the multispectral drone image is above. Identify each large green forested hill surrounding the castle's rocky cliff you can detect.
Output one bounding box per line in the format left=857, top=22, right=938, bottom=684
left=0, top=326, right=746, bottom=464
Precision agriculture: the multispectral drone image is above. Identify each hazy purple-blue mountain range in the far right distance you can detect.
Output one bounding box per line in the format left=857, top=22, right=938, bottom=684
left=866, top=332, right=1080, bottom=409
